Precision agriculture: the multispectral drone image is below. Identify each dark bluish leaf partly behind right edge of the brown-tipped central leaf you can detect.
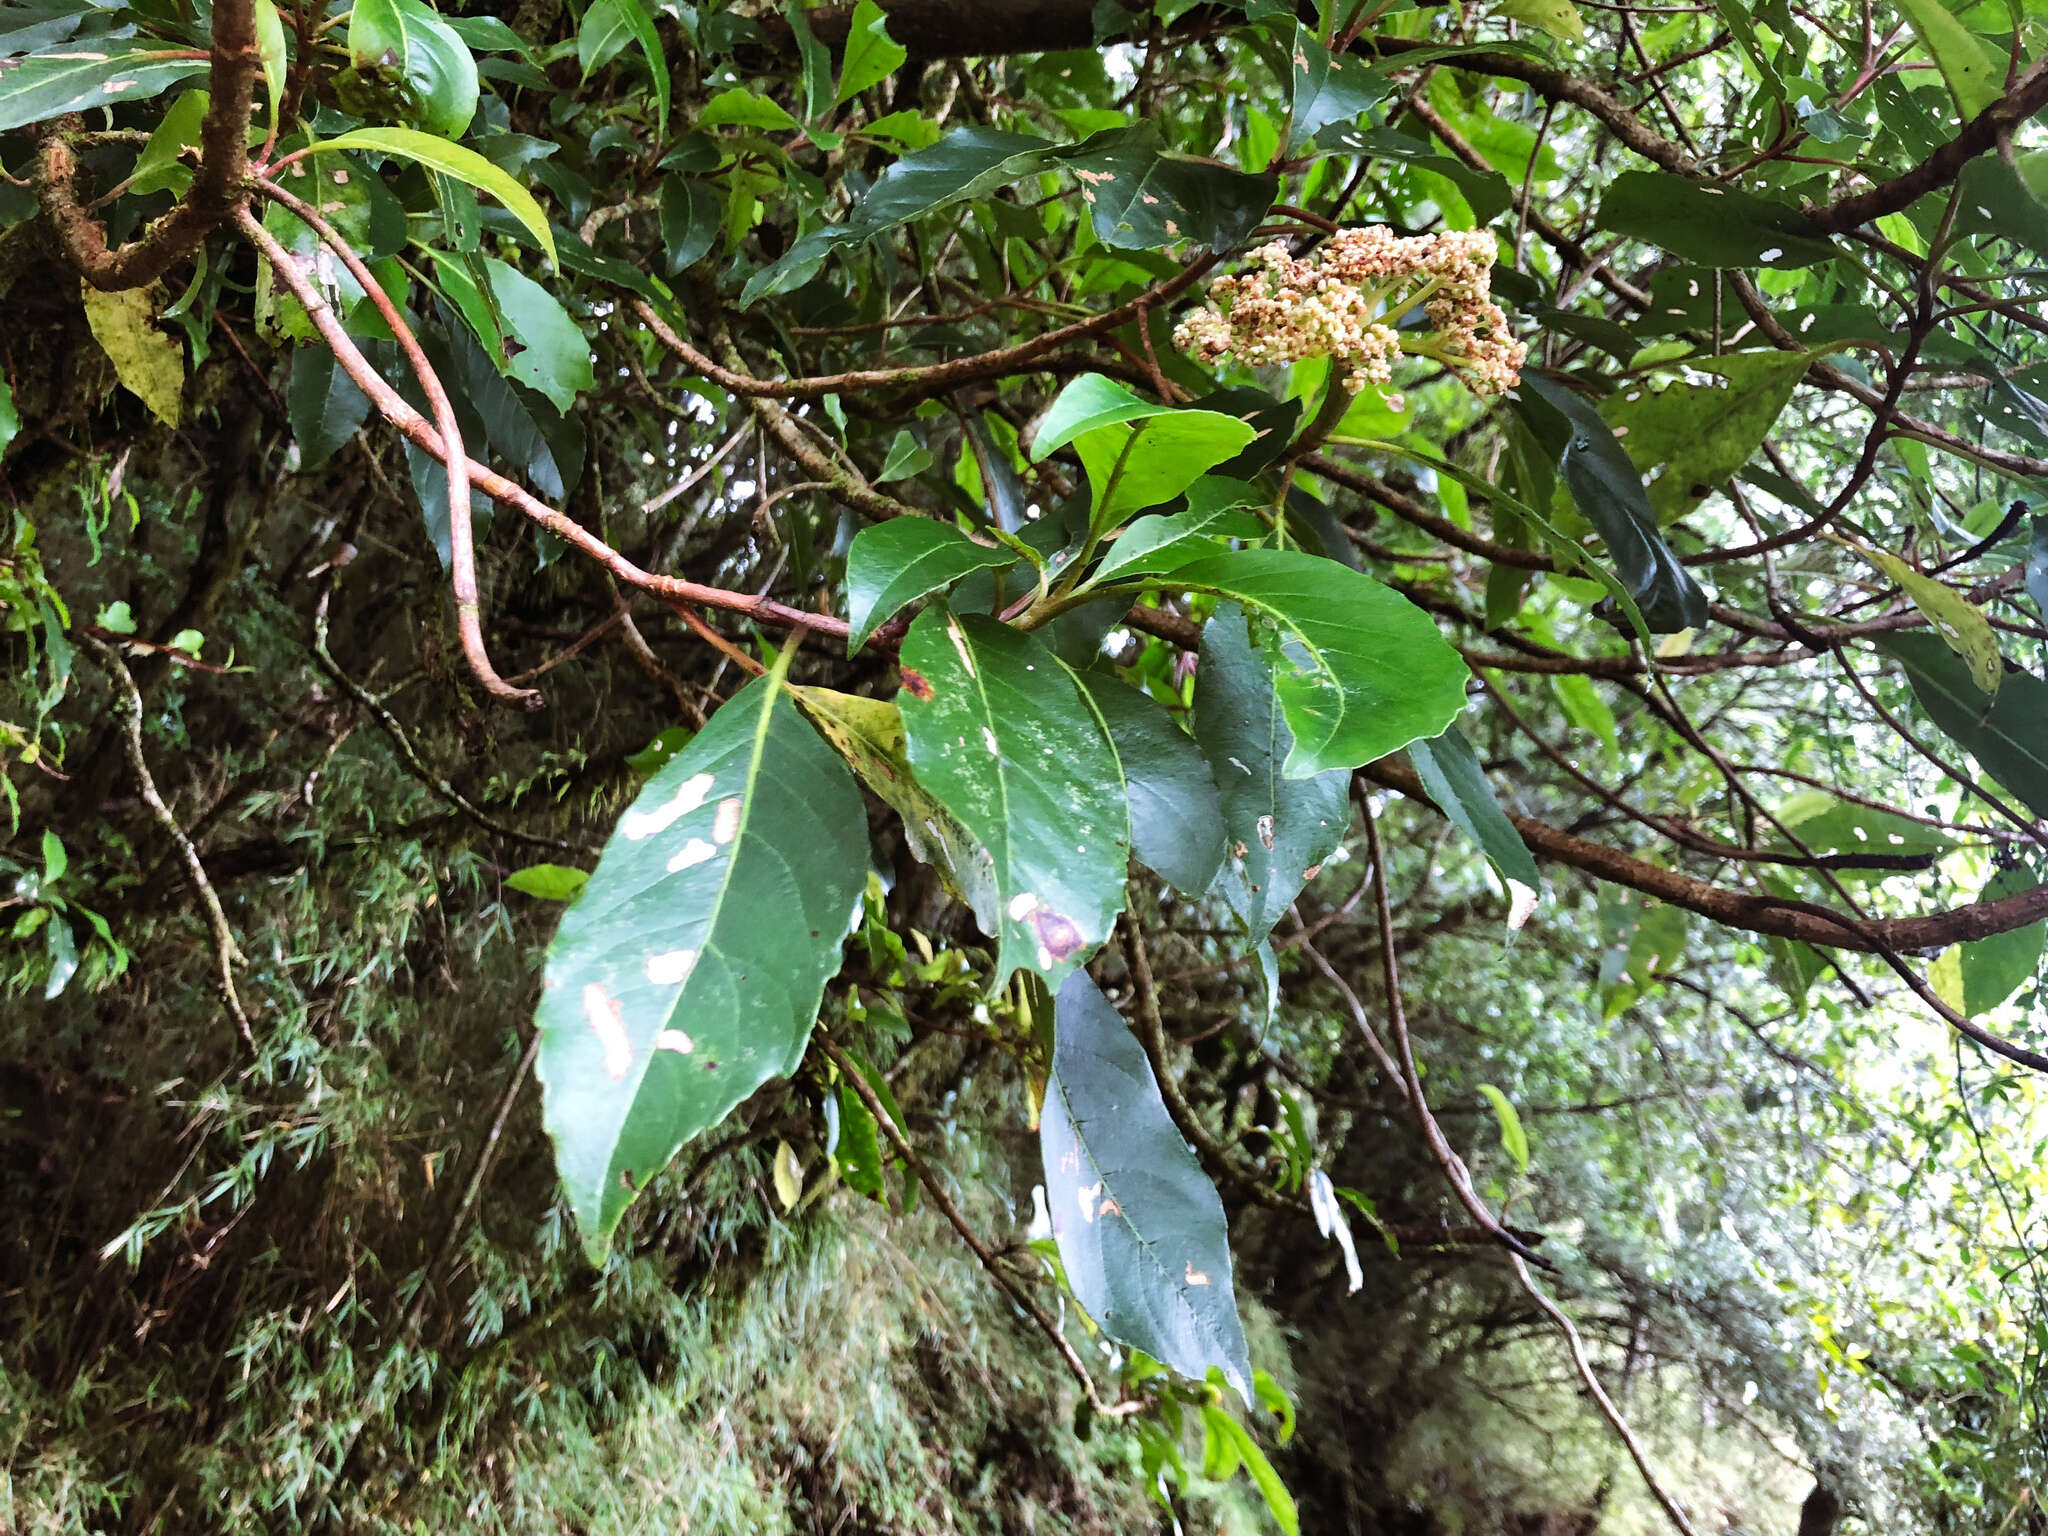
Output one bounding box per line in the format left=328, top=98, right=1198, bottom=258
left=1079, top=672, right=1223, bottom=897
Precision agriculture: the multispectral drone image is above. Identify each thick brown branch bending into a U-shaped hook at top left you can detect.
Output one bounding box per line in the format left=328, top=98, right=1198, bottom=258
left=37, top=0, right=262, bottom=293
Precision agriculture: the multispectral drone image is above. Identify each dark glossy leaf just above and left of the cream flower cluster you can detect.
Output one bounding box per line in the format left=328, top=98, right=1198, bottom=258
left=1059, top=123, right=1280, bottom=252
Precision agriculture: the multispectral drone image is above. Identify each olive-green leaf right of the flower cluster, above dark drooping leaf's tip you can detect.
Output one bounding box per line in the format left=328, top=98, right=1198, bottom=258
left=1599, top=350, right=1812, bottom=526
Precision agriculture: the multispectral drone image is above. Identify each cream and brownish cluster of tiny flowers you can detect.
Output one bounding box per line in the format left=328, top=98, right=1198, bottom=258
left=1174, top=225, right=1528, bottom=395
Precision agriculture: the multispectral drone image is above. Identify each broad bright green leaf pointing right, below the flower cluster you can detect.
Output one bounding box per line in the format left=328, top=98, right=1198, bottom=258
left=1122, top=543, right=1470, bottom=778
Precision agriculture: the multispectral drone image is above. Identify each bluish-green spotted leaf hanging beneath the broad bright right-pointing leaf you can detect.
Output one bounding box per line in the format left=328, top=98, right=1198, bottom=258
left=1194, top=606, right=1352, bottom=942
